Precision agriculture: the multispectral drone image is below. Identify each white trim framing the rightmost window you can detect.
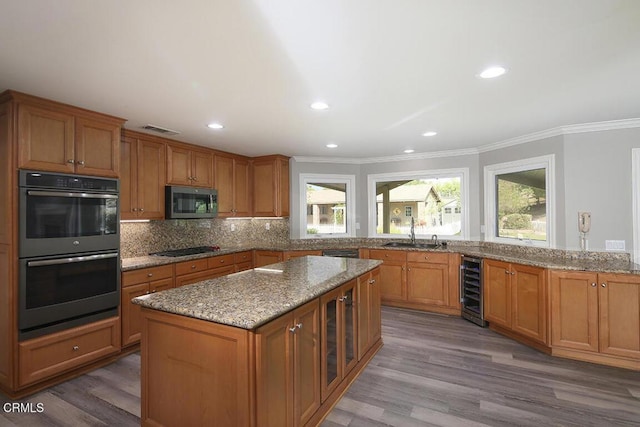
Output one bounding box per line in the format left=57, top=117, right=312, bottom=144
left=484, top=154, right=556, bottom=248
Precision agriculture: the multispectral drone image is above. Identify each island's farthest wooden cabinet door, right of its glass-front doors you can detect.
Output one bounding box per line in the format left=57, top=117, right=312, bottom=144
left=356, top=268, right=382, bottom=360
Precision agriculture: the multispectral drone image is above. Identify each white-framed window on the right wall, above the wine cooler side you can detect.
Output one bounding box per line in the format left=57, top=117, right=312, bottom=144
left=485, top=155, right=555, bottom=247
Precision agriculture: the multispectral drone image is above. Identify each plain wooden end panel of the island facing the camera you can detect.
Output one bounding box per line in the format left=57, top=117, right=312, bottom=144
left=141, top=308, right=255, bottom=426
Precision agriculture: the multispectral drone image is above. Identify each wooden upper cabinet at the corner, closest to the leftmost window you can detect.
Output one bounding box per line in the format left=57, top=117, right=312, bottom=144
left=253, top=155, right=289, bottom=216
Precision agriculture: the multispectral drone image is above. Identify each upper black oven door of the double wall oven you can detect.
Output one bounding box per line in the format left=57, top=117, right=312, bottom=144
left=20, top=188, right=120, bottom=257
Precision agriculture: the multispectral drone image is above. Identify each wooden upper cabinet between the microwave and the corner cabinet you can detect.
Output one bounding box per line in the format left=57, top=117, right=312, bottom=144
left=218, top=153, right=252, bottom=217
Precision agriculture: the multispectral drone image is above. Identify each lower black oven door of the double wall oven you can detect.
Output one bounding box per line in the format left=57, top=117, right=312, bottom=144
left=18, top=251, right=120, bottom=335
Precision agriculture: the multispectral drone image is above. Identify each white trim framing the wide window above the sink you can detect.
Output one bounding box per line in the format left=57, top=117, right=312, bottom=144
left=367, top=168, right=469, bottom=240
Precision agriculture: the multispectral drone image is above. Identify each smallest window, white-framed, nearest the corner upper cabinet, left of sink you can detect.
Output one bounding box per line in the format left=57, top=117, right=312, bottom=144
left=300, top=174, right=355, bottom=238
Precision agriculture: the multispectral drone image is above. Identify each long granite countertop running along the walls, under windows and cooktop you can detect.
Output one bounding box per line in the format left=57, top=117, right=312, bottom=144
left=121, top=241, right=640, bottom=274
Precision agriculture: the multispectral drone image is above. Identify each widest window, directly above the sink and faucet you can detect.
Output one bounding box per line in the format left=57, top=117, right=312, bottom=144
left=368, top=168, right=469, bottom=239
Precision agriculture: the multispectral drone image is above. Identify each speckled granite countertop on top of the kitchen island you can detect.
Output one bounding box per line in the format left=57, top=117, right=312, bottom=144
left=133, top=256, right=382, bottom=330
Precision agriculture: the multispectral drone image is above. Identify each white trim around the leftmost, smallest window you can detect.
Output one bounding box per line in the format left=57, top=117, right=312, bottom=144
left=299, top=173, right=356, bottom=239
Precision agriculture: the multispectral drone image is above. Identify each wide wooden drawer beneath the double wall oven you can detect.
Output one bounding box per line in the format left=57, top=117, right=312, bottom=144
left=18, top=317, right=120, bottom=386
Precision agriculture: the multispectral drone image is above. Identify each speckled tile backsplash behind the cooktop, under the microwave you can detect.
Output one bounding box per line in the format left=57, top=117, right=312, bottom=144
left=120, top=218, right=289, bottom=258
